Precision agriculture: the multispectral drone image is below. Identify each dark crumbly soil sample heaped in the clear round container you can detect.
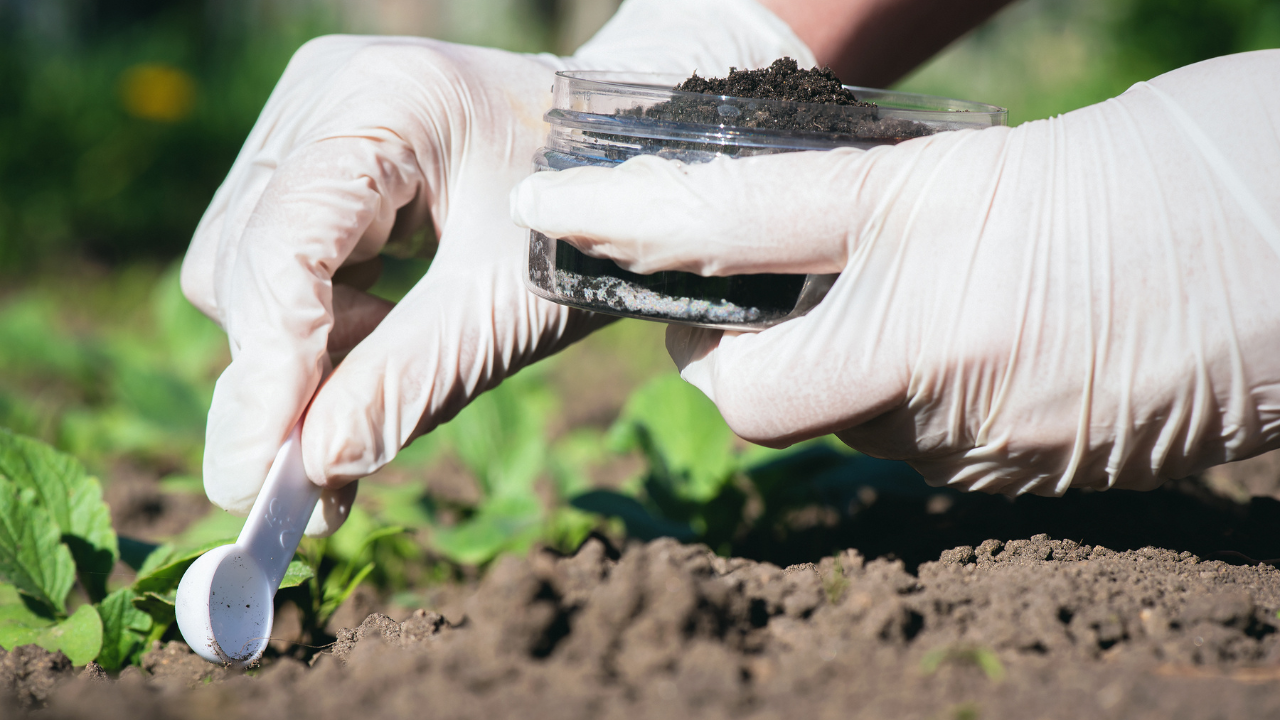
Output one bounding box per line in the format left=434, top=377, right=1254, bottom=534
left=529, top=58, right=962, bottom=329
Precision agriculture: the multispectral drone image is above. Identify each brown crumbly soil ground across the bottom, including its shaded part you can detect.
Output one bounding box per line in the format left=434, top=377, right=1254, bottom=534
left=0, top=450, right=1280, bottom=720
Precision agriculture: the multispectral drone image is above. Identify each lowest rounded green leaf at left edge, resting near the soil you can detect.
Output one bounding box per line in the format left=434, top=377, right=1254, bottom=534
left=0, top=583, right=102, bottom=665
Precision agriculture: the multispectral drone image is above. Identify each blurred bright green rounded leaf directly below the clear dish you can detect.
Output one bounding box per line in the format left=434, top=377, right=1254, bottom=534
left=609, top=373, right=739, bottom=503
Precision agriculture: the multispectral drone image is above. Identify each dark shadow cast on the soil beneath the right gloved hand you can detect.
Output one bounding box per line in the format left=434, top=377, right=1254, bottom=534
left=732, top=456, right=1280, bottom=573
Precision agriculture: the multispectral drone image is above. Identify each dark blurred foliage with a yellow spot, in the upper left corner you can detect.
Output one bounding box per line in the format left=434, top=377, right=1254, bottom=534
left=0, top=0, right=334, bottom=269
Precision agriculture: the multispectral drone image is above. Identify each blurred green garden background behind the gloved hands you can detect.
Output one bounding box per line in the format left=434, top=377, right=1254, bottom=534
left=0, top=0, right=1280, bottom=618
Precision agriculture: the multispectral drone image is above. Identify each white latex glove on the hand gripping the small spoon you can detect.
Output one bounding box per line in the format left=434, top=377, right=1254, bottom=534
left=182, top=0, right=813, bottom=534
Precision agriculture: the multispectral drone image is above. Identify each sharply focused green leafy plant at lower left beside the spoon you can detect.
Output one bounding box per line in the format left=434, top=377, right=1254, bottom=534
left=0, top=430, right=312, bottom=670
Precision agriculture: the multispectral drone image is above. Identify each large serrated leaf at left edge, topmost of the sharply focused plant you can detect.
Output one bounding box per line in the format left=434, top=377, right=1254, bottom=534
left=0, top=430, right=119, bottom=600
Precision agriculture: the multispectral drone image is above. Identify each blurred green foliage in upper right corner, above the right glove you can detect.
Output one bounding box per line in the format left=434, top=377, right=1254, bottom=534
left=901, top=0, right=1280, bottom=124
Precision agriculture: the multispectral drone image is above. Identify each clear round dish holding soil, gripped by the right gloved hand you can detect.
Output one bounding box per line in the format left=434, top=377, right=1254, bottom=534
left=525, top=72, right=1009, bottom=331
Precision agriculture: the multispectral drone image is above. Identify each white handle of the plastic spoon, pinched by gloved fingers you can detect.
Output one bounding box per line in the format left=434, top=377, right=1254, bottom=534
left=236, top=421, right=320, bottom=593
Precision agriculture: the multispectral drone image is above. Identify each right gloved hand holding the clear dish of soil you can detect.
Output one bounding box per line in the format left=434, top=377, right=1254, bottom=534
left=512, top=51, right=1280, bottom=495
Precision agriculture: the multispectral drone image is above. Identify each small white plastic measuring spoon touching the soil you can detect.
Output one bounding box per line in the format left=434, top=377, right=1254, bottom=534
left=175, top=423, right=320, bottom=667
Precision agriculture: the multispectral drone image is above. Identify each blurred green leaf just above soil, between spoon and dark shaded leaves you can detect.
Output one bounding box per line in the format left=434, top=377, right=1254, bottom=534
left=431, top=497, right=543, bottom=565
